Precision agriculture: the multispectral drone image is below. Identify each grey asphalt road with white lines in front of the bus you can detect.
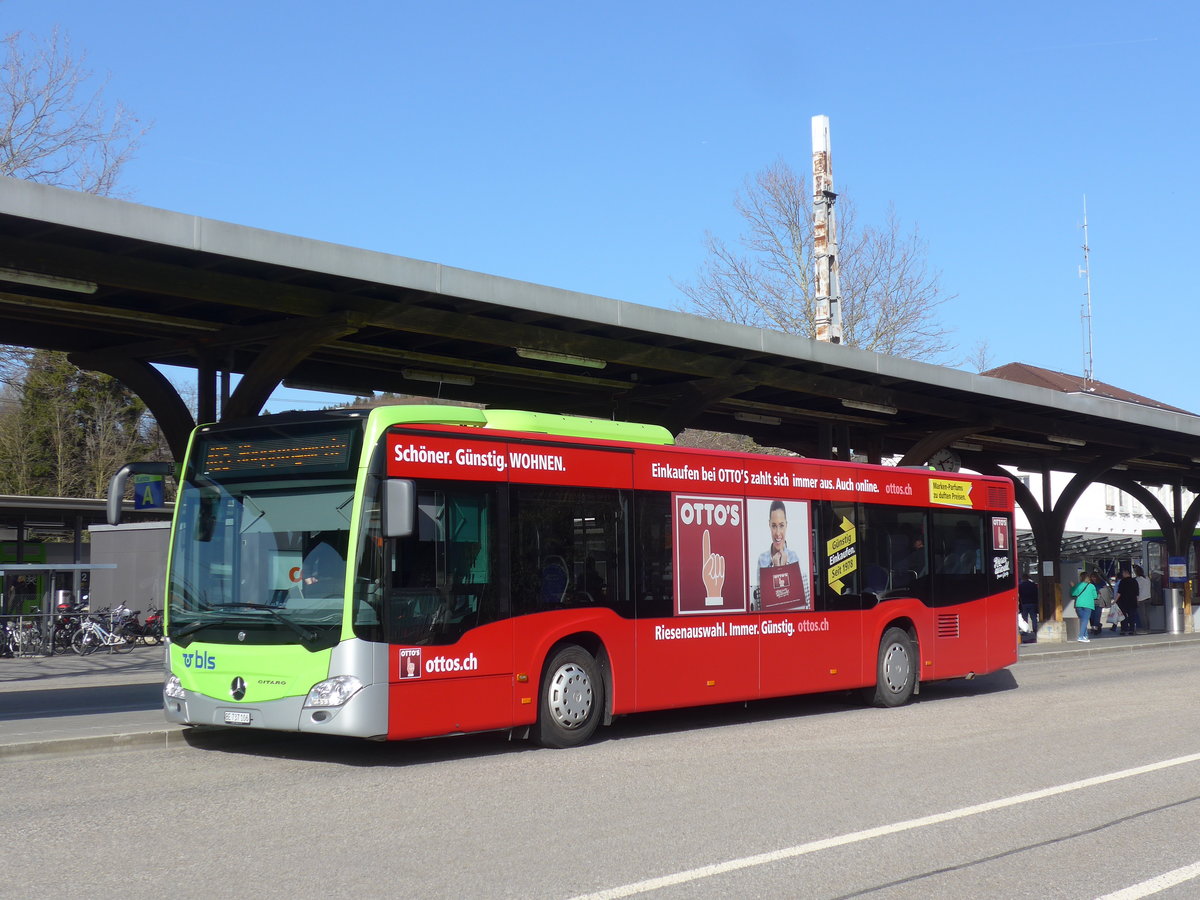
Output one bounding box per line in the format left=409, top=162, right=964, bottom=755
left=7, top=646, right=1200, bottom=899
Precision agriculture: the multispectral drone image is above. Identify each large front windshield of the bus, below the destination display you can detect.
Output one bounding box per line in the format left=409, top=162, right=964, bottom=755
left=168, top=476, right=354, bottom=647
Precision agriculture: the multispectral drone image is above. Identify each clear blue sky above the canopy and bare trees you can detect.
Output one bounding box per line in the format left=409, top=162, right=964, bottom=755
left=9, top=0, right=1200, bottom=412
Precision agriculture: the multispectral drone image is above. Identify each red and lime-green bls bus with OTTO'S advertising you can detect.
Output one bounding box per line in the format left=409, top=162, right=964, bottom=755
left=110, top=404, right=1018, bottom=746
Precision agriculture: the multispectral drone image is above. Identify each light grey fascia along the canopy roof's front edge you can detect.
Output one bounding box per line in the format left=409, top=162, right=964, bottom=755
left=0, top=176, right=1200, bottom=436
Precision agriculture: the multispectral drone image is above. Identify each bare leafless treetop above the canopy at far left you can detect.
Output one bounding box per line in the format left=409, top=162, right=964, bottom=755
left=0, top=29, right=145, bottom=194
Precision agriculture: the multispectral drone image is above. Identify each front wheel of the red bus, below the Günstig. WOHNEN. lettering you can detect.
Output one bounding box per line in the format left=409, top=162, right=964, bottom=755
left=534, top=644, right=604, bottom=749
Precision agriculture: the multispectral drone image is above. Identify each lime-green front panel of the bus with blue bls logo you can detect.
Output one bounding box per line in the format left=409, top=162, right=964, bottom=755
left=170, top=641, right=332, bottom=704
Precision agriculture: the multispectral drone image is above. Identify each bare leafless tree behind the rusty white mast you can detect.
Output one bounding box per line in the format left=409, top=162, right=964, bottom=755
left=677, top=162, right=952, bottom=360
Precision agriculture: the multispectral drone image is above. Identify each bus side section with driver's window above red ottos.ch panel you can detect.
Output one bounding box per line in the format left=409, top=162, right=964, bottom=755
left=384, top=482, right=512, bottom=738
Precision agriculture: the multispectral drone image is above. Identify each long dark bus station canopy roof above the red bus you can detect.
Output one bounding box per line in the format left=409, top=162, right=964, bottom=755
left=0, top=179, right=1200, bottom=501
